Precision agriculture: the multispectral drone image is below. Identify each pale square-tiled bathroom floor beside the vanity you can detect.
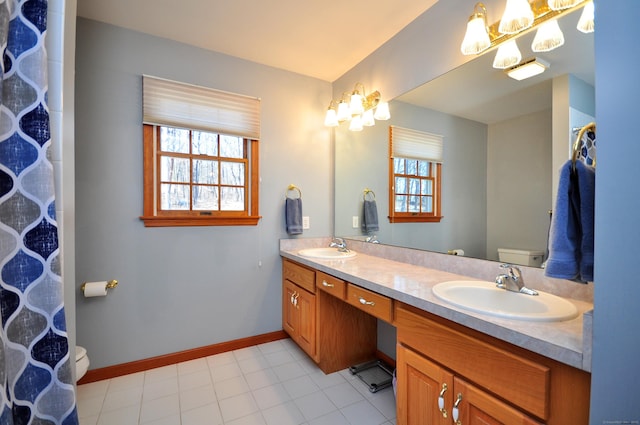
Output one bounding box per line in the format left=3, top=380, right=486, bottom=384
left=78, top=339, right=396, bottom=425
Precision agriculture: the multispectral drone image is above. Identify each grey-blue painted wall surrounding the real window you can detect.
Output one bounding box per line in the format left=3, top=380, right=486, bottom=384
left=75, top=19, right=333, bottom=368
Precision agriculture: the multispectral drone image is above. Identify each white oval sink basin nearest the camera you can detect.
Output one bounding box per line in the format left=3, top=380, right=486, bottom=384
left=433, top=280, right=578, bottom=322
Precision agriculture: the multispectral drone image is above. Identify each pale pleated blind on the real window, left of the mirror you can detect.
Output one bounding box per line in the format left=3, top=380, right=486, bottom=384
left=142, top=75, right=260, bottom=139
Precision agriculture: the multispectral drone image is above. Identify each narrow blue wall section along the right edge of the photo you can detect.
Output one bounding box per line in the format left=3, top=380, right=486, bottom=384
left=591, top=0, right=640, bottom=425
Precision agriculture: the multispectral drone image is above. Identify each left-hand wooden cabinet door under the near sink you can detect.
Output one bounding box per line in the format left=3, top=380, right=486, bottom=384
left=396, top=345, right=453, bottom=425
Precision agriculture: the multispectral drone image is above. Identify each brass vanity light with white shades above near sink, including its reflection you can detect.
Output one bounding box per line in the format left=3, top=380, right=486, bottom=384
left=460, top=0, right=593, bottom=74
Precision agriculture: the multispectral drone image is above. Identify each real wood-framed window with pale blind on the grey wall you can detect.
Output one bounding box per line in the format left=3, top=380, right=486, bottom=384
left=140, top=75, right=260, bottom=227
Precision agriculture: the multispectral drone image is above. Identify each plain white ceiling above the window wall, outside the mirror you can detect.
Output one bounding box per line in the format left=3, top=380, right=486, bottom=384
left=78, top=0, right=438, bottom=82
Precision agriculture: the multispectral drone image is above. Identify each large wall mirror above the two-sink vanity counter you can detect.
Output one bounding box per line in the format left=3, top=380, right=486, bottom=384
left=335, top=6, right=595, bottom=260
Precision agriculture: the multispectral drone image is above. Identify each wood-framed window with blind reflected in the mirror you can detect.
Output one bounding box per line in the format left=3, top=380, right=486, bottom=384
left=389, top=126, right=443, bottom=223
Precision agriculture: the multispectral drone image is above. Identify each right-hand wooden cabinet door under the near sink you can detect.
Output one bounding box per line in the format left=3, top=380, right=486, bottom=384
left=452, top=377, right=541, bottom=425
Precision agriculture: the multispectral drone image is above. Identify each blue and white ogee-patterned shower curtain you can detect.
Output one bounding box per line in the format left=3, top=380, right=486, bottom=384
left=0, top=0, right=78, bottom=425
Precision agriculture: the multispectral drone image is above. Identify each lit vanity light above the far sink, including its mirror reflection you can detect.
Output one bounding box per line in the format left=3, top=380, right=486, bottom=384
left=324, top=83, right=391, bottom=131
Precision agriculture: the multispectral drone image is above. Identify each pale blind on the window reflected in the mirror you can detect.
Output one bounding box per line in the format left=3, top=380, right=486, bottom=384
left=391, top=125, right=443, bottom=162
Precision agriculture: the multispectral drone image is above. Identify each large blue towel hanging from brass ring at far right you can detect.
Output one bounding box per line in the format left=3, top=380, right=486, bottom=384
left=545, top=161, right=595, bottom=282
